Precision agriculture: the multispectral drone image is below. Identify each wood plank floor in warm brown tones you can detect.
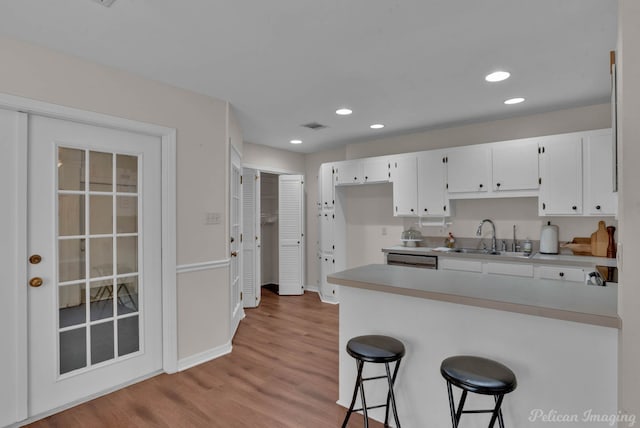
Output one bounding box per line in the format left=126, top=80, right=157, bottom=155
left=29, top=289, right=382, bottom=428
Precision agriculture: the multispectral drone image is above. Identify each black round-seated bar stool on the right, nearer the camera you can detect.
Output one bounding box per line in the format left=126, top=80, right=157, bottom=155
left=440, top=355, right=518, bottom=428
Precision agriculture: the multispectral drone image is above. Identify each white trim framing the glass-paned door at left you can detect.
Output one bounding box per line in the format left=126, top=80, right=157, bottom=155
left=0, top=93, right=178, bottom=419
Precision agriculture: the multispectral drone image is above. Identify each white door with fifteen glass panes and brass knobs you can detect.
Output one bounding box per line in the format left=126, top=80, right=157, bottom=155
left=28, top=116, right=162, bottom=415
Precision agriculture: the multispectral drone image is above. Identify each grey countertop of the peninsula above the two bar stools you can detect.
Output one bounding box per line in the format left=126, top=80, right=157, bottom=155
left=327, top=264, right=620, bottom=328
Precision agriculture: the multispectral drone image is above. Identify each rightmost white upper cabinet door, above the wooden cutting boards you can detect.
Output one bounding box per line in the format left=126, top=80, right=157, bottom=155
left=582, top=129, right=618, bottom=215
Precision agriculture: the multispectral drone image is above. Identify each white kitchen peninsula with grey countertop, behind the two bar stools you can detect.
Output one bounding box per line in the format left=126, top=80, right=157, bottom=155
left=328, top=265, right=620, bottom=427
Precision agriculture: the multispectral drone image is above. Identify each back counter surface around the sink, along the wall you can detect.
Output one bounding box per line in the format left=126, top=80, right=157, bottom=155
left=382, top=245, right=617, bottom=267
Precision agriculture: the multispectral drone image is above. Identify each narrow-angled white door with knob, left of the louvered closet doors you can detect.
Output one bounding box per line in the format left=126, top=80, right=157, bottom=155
left=229, top=147, right=244, bottom=336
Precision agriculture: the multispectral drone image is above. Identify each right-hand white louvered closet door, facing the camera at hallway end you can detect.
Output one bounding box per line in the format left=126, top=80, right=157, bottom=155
left=278, top=175, right=304, bottom=295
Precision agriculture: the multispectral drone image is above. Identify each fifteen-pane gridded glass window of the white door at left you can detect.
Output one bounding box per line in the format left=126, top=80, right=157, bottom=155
left=56, top=146, right=142, bottom=375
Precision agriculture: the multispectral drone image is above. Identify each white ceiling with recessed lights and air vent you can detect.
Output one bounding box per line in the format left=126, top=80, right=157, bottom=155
left=0, top=0, right=617, bottom=153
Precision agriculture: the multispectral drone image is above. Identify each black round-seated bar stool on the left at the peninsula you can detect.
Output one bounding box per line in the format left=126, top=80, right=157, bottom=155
left=342, top=335, right=404, bottom=428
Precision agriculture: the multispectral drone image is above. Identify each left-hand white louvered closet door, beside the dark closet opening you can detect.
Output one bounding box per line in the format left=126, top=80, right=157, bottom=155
left=242, top=168, right=261, bottom=308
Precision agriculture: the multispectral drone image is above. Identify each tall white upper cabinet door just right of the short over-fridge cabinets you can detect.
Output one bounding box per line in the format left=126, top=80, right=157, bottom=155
left=391, top=155, right=418, bottom=216
